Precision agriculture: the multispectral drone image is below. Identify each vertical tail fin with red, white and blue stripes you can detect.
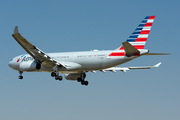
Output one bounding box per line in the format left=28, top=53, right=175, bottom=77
left=118, top=16, right=155, bottom=50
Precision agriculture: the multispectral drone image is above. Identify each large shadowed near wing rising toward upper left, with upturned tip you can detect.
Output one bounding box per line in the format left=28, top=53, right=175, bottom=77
left=12, top=26, right=65, bottom=68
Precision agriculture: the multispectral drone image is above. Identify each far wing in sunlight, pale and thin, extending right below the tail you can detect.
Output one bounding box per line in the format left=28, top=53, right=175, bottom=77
left=100, top=62, right=161, bottom=72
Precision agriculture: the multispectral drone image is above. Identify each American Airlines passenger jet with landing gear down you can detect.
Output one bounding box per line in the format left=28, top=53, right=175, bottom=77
left=8, top=16, right=167, bottom=86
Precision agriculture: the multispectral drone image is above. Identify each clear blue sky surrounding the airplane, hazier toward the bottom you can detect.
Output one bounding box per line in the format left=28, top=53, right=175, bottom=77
left=0, top=0, right=180, bottom=120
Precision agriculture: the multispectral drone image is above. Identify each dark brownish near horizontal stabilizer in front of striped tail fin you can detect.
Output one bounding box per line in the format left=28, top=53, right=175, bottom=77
left=122, top=41, right=140, bottom=57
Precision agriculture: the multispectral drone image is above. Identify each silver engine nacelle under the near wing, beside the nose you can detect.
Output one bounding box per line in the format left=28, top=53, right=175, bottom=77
left=19, top=61, right=41, bottom=71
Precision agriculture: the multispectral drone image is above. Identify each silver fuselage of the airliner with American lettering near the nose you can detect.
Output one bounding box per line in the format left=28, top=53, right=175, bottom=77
left=9, top=50, right=148, bottom=73
